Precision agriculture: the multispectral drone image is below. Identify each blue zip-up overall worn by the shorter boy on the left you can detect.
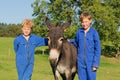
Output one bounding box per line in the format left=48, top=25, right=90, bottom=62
left=14, top=34, right=47, bottom=80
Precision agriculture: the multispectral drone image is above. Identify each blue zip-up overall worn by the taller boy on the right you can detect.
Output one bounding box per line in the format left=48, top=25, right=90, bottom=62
left=75, top=28, right=101, bottom=80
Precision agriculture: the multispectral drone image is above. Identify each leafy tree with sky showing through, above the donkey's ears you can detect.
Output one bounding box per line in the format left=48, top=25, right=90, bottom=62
left=32, top=0, right=81, bottom=26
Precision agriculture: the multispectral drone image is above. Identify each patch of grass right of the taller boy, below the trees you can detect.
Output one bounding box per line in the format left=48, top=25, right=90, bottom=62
left=97, top=56, right=120, bottom=80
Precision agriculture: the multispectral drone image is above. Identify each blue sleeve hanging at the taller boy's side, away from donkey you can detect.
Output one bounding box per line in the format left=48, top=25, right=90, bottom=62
left=93, top=31, right=101, bottom=67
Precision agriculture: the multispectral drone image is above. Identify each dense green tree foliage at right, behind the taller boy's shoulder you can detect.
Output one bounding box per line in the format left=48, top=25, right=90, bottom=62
left=78, top=0, right=120, bottom=56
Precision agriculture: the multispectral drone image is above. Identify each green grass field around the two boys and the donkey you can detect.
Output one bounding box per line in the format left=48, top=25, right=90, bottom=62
left=0, top=38, right=120, bottom=80
